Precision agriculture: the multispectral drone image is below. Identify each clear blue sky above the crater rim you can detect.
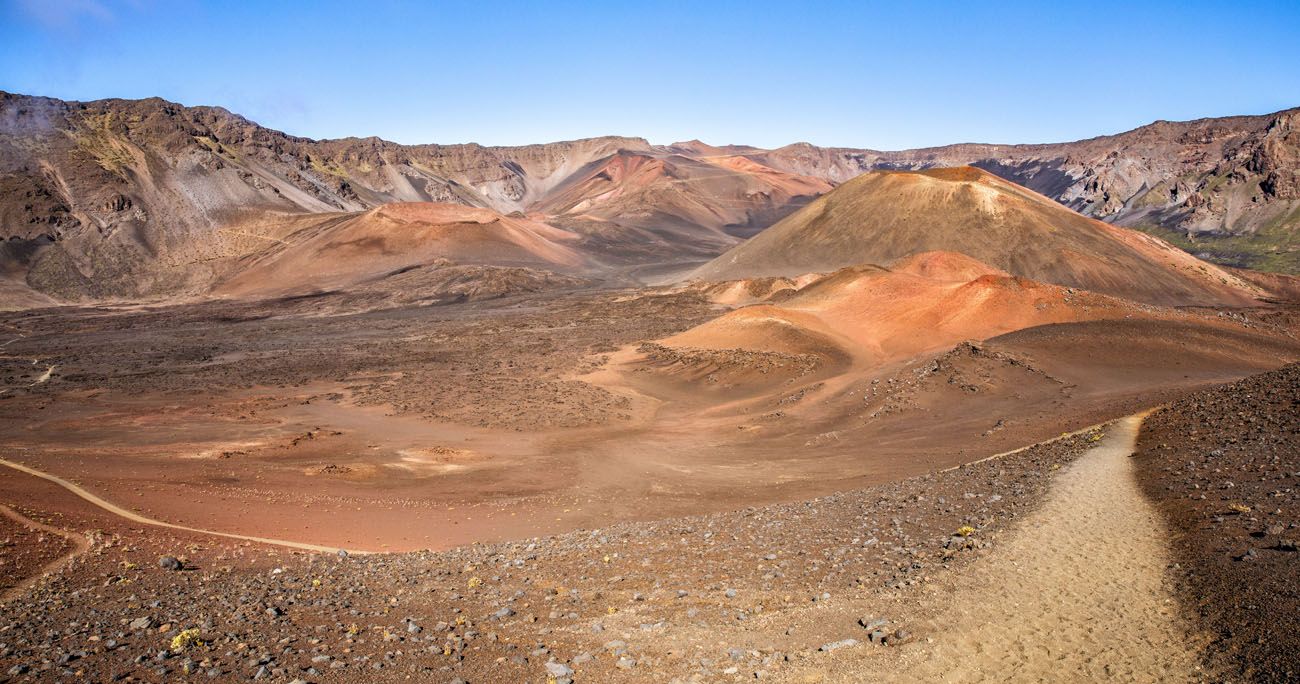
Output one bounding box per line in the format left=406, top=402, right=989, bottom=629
left=0, top=0, right=1300, bottom=150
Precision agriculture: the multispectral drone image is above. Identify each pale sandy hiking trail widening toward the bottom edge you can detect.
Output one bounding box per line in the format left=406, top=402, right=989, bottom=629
left=796, top=416, right=1205, bottom=683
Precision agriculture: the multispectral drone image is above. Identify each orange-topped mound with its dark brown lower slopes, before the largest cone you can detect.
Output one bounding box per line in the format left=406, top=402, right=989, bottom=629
left=603, top=252, right=1295, bottom=494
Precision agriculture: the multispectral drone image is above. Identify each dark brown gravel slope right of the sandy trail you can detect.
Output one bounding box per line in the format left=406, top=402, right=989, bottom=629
left=1136, top=365, right=1300, bottom=681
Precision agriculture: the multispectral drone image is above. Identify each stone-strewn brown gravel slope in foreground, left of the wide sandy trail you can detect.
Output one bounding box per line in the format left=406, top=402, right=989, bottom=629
left=0, top=434, right=1092, bottom=683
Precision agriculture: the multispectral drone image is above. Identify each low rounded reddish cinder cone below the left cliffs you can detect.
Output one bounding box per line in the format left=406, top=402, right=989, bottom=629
left=216, top=202, right=594, bottom=296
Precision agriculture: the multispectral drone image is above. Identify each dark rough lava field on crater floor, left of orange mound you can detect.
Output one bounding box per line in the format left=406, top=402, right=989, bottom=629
left=0, top=290, right=716, bottom=430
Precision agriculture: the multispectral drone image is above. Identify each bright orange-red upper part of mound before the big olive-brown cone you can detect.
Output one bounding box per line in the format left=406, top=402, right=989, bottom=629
left=663, top=252, right=1174, bottom=365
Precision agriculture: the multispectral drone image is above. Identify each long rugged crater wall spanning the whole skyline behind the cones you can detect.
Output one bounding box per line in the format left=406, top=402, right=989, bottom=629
left=0, top=92, right=1300, bottom=300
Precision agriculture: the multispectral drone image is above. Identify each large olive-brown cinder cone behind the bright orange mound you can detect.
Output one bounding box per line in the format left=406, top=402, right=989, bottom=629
left=693, top=166, right=1264, bottom=306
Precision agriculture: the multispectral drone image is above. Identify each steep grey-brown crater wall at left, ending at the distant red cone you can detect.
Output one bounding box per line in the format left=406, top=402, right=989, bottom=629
left=0, top=94, right=649, bottom=299
